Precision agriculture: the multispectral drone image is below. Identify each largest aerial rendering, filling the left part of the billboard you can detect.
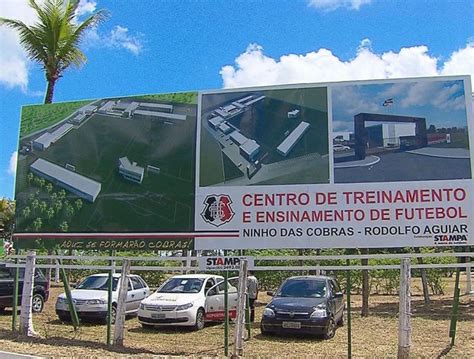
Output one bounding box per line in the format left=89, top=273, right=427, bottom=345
left=16, top=93, right=197, bottom=232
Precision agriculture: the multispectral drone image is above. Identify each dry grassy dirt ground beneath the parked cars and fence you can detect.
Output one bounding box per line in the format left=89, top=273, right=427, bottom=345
left=0, top=276, right=474, bottom=358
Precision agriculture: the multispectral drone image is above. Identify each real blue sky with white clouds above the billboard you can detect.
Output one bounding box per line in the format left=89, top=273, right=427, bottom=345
left=0, top=0, right=474, bottom=198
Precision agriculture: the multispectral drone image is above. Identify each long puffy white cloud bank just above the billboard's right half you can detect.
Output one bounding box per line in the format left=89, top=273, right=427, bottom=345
left=220, top=39, right=474, bottom=88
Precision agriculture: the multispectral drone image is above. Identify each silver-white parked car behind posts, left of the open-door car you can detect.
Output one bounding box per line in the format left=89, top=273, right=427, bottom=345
left=56, top=273, right=150, bottom=321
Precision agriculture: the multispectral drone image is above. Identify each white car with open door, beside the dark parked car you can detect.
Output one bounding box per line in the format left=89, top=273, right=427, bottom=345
left=138, top=274, right=237, bottom=330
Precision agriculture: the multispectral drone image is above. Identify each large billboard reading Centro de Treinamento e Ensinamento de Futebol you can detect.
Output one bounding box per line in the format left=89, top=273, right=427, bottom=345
left=12, top=76, right=474, bottom=249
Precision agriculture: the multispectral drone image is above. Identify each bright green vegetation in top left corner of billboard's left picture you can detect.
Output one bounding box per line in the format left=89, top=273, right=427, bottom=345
left=20, top=100, right=91, bottom=138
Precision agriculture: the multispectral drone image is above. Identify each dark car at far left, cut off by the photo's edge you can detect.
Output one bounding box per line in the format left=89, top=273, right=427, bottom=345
left=0, top=263, right=49, bottom=313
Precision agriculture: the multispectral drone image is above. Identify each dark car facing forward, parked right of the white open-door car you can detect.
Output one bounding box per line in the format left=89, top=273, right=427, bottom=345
left=260, top=276, right=344, bottom=339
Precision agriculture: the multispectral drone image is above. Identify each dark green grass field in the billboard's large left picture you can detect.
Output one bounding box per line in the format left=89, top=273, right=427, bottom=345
left=16, top=105, right=196, bottom=232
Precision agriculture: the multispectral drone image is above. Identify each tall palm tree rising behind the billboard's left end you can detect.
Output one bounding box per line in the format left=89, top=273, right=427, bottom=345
left=0, top=0, right=108, bottom=103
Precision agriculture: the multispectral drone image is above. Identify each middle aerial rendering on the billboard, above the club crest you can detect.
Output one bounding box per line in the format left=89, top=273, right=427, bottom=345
left=199, top=88, right=329, bottom=187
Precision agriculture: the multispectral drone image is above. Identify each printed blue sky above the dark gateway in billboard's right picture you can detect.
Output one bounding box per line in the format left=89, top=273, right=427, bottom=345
left=332, top=79, right=467, bottom=132
